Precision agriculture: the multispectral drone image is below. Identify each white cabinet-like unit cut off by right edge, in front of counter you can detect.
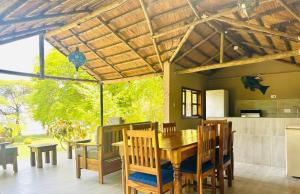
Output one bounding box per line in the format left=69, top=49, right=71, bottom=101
left=285, top=126, right=300, bottom=177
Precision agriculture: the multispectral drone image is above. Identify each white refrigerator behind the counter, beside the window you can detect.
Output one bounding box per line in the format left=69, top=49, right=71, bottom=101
left=205, top=89, right=229, bottom=118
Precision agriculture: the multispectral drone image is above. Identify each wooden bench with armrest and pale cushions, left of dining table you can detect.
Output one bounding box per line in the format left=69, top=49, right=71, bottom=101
left=76, top=124, right=150, bottom=184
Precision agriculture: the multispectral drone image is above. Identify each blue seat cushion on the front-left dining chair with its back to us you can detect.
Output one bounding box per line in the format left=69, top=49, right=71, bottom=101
left=128, top=169, right=174, bottom=187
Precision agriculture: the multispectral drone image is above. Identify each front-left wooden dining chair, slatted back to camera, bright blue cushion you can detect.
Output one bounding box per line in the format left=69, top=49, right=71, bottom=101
left=123, top=127, right=173, bottom=194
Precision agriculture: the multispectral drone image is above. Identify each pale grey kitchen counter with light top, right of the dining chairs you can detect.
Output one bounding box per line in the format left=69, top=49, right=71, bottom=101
left=209, top=117, right=300, bottom=168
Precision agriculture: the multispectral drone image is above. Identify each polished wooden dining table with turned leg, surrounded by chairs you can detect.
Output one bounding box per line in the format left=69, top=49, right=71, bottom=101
left=112, top=129, right=198, bottom=194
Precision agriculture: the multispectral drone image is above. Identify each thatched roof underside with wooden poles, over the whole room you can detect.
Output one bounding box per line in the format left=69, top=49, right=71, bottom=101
left=0, top=0, right=300, bottom=80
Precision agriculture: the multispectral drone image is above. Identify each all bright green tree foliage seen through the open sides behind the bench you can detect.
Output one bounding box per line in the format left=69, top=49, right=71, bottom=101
left=29, top=49, right=163, bottom=133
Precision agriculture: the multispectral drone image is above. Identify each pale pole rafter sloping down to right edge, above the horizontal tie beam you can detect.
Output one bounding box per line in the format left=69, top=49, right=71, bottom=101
left=216, top=17, right=300, bottom=42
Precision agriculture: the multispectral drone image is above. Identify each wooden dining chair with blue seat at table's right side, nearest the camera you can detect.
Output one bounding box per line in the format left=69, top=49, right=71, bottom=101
left=180, top=125, right=216, bottom=194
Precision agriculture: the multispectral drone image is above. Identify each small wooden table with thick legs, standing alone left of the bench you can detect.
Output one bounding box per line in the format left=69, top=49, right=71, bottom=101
left=28, top=144, right=57, bottom=168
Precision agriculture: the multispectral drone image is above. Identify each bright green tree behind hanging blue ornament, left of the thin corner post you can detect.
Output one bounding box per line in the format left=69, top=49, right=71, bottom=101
left=29, top=49, right=99, bottom=131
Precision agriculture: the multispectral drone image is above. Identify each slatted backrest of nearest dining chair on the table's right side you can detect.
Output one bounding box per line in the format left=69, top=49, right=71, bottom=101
left=197, top=125, right=216, bottom=175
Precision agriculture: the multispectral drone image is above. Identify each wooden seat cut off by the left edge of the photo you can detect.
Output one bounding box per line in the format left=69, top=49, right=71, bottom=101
left=0, top=142, right=18, bottom=173
